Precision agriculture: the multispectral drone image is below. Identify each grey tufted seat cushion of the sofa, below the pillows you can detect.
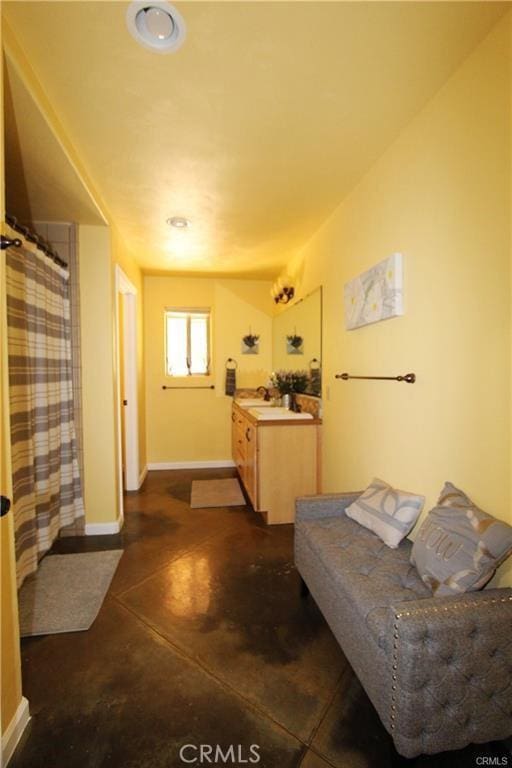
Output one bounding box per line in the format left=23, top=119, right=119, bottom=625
left=296, top=515, right=431, bottom=651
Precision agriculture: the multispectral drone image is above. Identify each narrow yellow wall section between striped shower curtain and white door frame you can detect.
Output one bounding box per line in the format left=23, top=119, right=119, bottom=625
left=78, top=225, right=119, bottom=523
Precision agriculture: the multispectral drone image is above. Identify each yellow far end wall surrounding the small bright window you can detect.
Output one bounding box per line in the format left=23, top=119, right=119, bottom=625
left=144, top=276, right=272, bottom=464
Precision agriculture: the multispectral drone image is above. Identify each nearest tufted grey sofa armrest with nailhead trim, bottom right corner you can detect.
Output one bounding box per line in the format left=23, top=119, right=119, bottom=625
left=387, top=589, right=512, bottom=757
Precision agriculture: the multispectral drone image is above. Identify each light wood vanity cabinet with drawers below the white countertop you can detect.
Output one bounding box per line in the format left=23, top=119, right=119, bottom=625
left=231, top=404, right=321, bottom=524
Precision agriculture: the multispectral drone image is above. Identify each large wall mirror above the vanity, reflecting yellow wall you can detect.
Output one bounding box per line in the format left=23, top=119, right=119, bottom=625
left=272, top=288, right=322, bottom=396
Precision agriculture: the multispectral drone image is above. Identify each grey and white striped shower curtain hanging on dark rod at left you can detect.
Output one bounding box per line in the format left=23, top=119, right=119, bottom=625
left=6, top=234, right=84, bottom=587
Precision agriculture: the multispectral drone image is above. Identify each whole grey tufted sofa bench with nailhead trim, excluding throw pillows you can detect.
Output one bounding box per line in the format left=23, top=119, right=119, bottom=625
left=295, top=493, right=512, bottom=757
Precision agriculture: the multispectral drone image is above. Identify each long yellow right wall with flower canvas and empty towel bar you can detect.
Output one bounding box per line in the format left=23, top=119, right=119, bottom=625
left=287, top=15, right=512, bottom=581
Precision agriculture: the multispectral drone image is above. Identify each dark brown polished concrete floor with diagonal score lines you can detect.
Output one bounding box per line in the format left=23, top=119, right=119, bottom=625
left=11, top=470, right=512, bottom=768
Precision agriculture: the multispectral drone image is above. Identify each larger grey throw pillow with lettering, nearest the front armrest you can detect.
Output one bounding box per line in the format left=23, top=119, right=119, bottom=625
left=411, top=483, right=512, bottom=595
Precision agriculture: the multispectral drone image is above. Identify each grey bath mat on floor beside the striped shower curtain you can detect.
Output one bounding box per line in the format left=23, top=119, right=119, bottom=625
left=19, top=549, right=123, bottom=637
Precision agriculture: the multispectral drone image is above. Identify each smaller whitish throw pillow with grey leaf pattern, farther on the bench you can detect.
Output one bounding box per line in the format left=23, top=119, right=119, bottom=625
left=345, top=478, right=425, bottom=549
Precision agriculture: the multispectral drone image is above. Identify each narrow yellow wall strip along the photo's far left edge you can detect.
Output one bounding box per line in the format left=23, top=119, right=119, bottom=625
left=0, top=7, right=21, bottom=736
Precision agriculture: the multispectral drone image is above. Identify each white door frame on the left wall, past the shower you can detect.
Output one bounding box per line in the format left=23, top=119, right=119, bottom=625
left=115, top=264, right=140, bottom=508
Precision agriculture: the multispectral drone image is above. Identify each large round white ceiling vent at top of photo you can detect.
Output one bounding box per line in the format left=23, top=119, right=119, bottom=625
left=126, top=0, right=185, bottom=53
